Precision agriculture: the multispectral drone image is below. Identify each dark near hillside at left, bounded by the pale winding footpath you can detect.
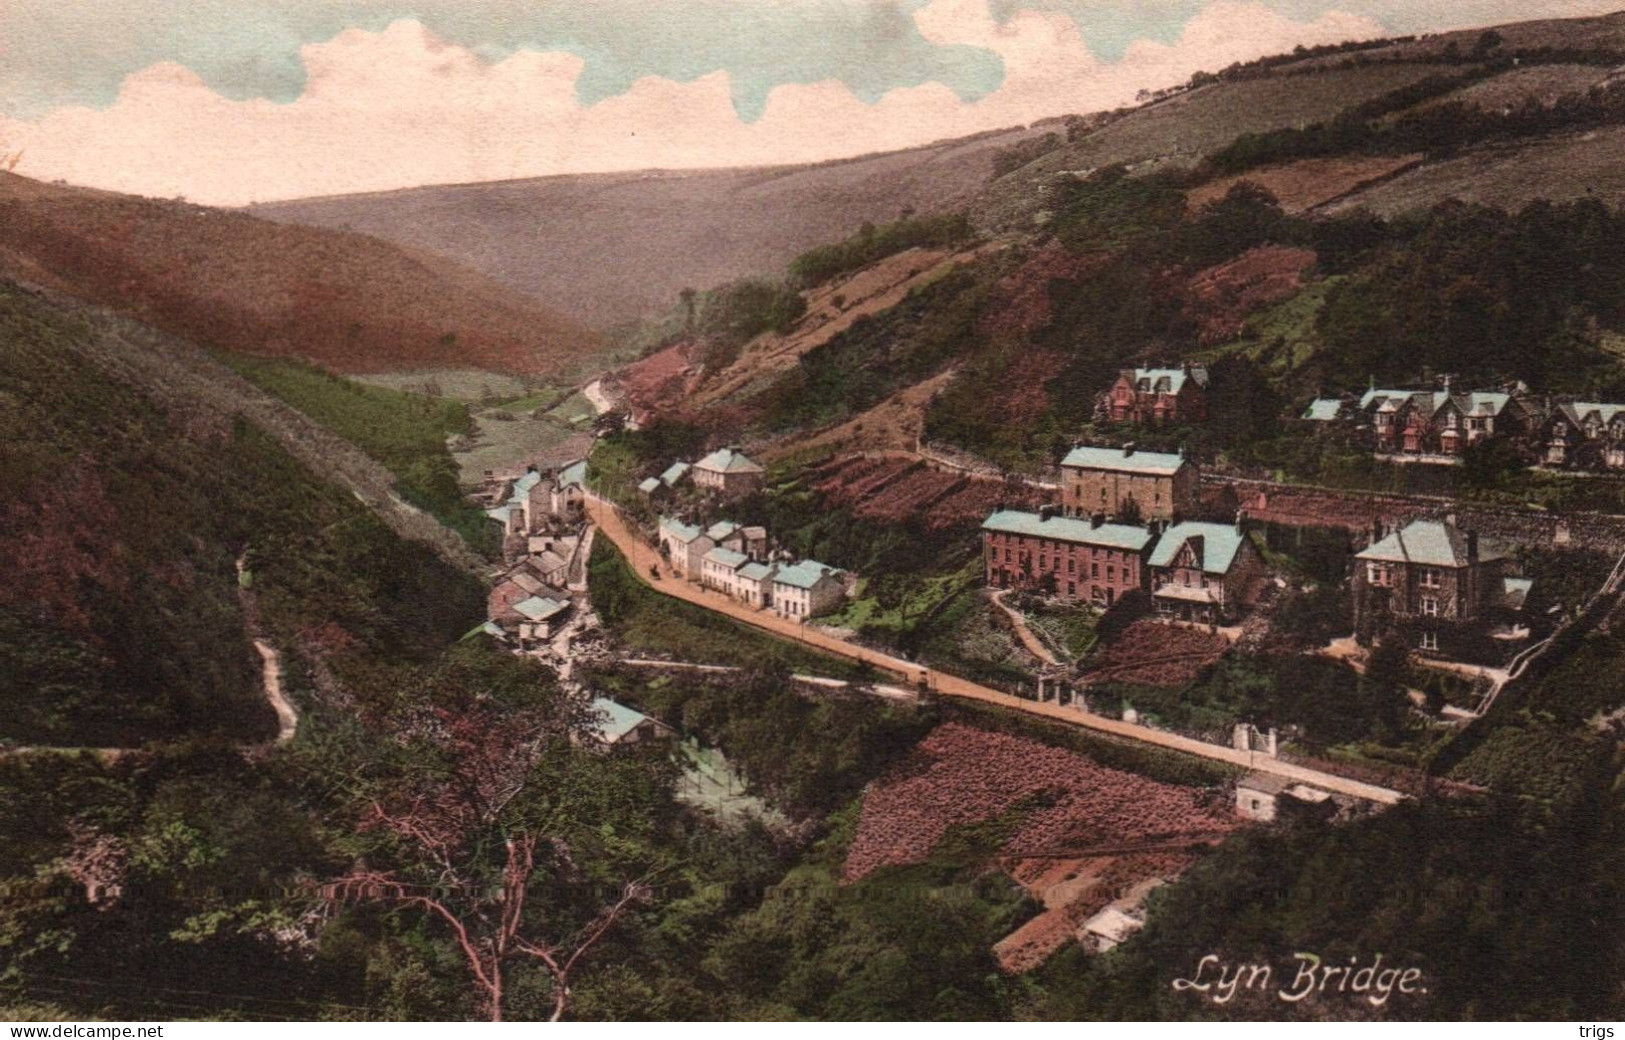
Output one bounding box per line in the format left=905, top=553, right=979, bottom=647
left=0, top=283, right=481, bottom=746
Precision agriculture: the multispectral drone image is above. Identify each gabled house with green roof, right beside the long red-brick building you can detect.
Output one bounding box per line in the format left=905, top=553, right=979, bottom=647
left=1151, top=522, right=1264, bottom=622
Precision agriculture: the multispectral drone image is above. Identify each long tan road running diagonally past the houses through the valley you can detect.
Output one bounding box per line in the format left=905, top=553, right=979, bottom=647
left=585, top=494, right=1404, bottom=804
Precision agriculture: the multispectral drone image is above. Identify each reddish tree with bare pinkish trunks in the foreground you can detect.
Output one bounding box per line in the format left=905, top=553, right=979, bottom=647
left=319, top=652, right=650, bottom=1022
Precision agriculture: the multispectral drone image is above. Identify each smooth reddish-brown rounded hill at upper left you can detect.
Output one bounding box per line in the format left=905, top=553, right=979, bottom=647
left=0, top=174, right=603, bottom=375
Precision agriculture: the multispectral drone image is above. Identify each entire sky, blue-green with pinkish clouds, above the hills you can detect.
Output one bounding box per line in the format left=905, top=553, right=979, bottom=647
left=0, top=0, right=1620, bottom=205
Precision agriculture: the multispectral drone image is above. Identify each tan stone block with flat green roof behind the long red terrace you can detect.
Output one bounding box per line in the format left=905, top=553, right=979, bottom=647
left=1061, top=444, right=1199, bottom=520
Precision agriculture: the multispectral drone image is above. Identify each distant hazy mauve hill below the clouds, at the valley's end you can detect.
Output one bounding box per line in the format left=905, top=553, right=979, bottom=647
left=252, top=127, right=1047, bottom=328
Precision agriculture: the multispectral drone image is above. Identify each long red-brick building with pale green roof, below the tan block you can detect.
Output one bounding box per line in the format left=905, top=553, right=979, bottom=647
left=982, top=509, right=1152, bottom=608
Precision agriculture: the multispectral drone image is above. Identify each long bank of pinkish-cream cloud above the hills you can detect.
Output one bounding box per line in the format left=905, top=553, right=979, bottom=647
left=0, top=0, right=1381, bottom=205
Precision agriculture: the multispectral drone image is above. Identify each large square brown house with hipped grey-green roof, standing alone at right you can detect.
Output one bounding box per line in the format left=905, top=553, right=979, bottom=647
left=1354, top=520, right=1528, bottom=650
